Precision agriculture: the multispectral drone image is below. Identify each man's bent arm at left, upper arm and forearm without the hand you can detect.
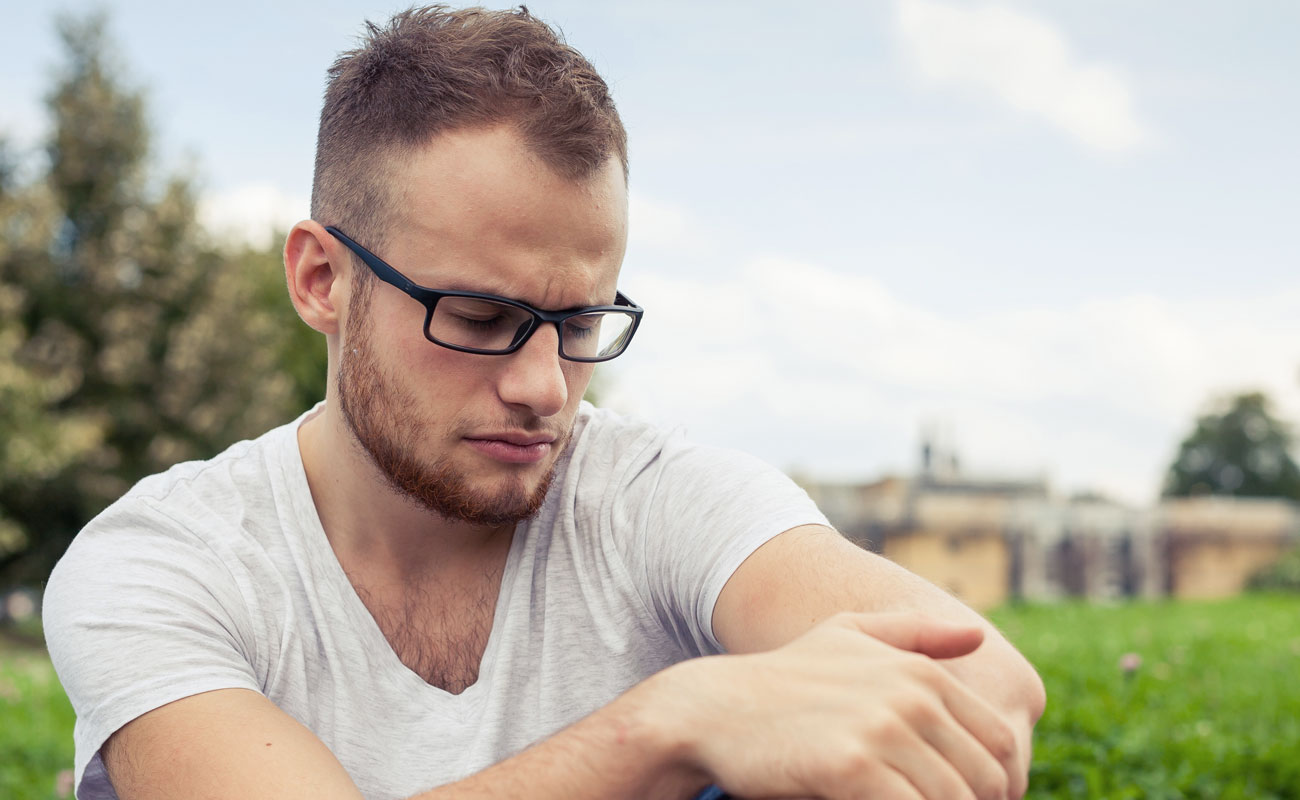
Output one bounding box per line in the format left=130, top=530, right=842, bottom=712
left=103, top=687, right=709, bottom=800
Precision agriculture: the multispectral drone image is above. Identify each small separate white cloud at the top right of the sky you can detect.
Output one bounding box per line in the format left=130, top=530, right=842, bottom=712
left=898, top=0, right=1153, bottom=152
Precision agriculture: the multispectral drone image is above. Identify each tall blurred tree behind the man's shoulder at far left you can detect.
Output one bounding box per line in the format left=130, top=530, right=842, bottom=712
left=0, top=17, right=325, bottom=584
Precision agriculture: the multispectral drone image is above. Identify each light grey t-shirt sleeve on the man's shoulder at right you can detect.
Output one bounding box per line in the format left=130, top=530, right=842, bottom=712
left=603, top=436, right=828, bottom=654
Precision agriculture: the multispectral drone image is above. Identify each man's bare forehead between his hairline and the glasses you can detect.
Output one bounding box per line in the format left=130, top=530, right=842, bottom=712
left=386, top=126, right=628, bottom=308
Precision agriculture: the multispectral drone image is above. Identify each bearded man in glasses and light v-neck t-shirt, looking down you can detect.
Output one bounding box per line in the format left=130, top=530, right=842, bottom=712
left=46, top=8, right=1044, bottom=800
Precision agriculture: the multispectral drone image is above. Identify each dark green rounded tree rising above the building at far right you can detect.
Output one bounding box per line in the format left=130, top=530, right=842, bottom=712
left=1164, top=392, right=1300, bottom=500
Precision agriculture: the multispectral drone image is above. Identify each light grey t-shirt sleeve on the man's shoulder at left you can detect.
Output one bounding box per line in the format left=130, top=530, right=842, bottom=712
left=43, top=500, right=260, bottom=800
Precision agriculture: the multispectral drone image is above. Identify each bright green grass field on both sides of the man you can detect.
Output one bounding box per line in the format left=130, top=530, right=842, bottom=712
left=0, top=596, right=1300, bottom=800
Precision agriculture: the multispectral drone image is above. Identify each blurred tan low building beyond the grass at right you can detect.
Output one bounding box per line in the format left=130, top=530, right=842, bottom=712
left=800, top=434, right=1300, bottom=609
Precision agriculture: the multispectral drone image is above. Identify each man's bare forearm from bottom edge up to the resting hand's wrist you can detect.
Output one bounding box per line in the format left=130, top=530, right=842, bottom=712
left=412, top=676, right=710, bottom=800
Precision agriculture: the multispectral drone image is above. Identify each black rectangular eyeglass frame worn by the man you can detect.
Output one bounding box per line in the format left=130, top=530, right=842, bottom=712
left=325, top=225, right=645, bottom=364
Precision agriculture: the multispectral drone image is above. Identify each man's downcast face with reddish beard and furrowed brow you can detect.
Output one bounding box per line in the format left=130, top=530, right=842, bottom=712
left=338, top=127, right=627, bottom=526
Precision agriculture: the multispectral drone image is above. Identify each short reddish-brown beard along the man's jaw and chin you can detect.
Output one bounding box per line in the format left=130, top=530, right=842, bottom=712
left=338, top=309, right=572, bottom=527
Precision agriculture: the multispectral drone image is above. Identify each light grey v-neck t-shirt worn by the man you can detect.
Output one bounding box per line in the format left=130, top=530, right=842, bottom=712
left=44, top=403, right=826, bottom=800
